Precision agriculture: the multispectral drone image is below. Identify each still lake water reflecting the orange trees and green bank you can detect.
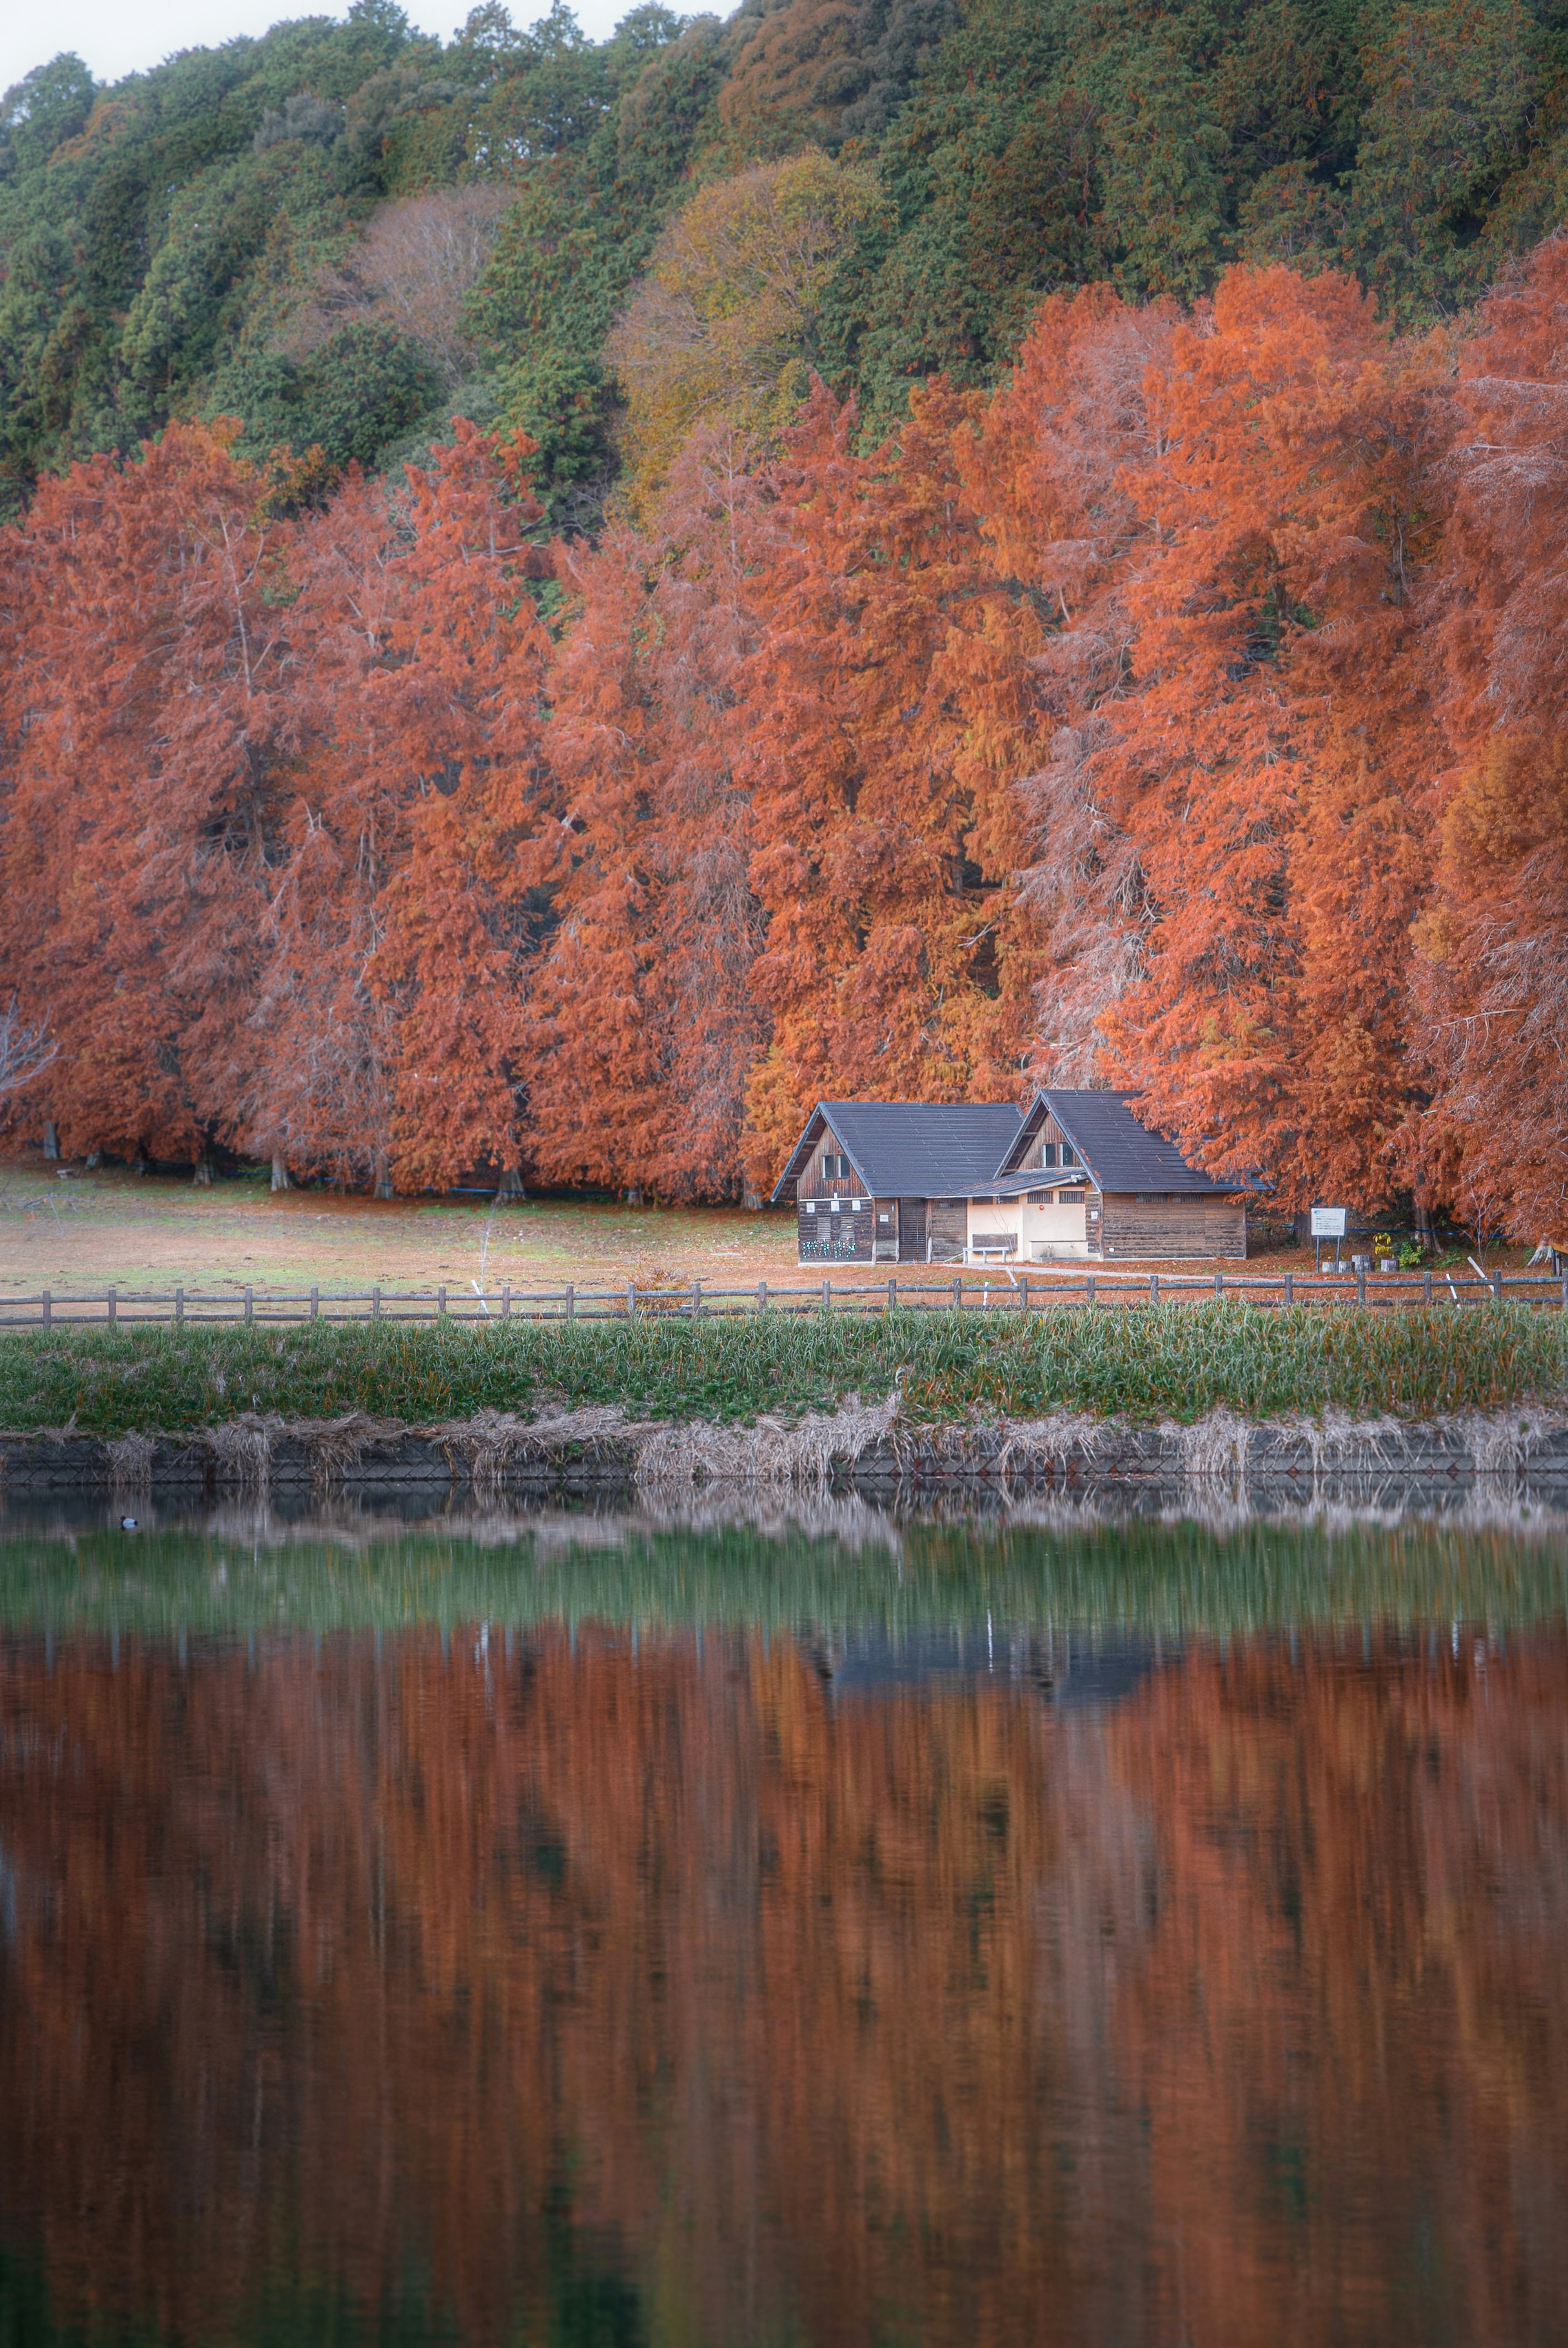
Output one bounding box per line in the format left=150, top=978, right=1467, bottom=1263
left=0, top=1510, right=1568, bottom=2348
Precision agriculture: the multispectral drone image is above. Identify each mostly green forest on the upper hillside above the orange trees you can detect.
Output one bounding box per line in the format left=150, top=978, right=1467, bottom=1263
left=0, top=0, right=1568, bottom=533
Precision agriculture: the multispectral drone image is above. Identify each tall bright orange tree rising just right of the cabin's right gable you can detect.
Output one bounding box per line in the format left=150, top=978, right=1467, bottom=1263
left=1108, top=270, right=1432, bottom=1204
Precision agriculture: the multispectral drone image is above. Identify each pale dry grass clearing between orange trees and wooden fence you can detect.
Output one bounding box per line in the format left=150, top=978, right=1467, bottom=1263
left=0, top=1153, right=1528, bottom=1296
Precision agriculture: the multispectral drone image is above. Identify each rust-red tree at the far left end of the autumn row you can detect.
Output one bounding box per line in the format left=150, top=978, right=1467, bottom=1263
left=0, top=427, right=298, bottom=1157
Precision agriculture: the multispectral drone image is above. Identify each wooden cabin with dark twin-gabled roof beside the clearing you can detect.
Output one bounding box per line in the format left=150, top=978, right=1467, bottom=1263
left=772, top=1092, right=1246, bottom=1263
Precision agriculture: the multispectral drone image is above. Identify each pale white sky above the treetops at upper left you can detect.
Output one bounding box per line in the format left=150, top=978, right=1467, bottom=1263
left=0, top=0, right=634, bottom=89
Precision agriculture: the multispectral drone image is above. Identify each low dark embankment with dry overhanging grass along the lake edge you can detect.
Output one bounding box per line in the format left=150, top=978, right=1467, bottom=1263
left=0, top=1390, right=1568, bottom=1501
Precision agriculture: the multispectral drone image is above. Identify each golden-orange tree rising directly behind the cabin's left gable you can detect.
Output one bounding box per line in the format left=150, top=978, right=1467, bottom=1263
left=744, top=385, right=1033, bottom=1183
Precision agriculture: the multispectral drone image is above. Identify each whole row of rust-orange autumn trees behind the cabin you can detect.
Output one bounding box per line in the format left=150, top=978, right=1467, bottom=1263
left=0, top=237, right=1568, bottom=1235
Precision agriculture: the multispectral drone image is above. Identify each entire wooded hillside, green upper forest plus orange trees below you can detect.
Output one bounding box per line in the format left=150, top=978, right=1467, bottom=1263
left=0, top=0, right=1568, bottom=1238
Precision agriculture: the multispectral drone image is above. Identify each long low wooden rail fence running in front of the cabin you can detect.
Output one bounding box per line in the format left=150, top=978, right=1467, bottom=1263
left=0, top=1268, right=1568, bottom=1329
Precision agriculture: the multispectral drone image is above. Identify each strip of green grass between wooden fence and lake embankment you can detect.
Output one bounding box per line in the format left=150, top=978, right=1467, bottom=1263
left=0, top=1303, right=1568, bottom=1435
